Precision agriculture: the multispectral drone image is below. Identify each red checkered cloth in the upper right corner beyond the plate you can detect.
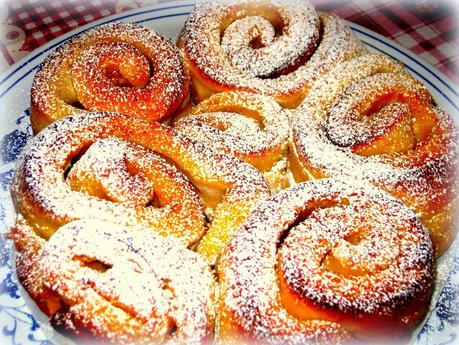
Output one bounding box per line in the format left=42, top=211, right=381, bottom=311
left=311, top=0, right=459, bottom=84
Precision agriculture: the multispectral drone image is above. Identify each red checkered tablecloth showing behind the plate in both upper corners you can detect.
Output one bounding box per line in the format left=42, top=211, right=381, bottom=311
left=0, top=0, right=459, bottom=84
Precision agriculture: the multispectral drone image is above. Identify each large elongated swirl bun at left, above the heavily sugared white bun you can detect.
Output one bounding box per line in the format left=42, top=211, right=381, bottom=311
left=11, top=113, right=269, bottom=260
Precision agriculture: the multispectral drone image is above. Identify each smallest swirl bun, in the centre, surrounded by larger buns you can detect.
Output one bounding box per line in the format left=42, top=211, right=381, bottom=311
left=174, top=91, right=290, bottom=190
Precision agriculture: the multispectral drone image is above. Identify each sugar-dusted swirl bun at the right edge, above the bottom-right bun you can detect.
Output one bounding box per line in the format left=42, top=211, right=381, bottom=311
left=290, top=55, right=457, bottom=255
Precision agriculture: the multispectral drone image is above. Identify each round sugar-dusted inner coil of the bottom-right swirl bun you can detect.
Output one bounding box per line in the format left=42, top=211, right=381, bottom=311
left=280, top=189, right=433, bottom=316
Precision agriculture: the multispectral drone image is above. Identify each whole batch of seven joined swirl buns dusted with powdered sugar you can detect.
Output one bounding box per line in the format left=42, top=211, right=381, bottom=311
left=6, top=0, right=459, bottom=345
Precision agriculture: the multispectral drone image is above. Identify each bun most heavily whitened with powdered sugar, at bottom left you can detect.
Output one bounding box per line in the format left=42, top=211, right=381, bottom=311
left=13, top=219, right=214, bottom=344
